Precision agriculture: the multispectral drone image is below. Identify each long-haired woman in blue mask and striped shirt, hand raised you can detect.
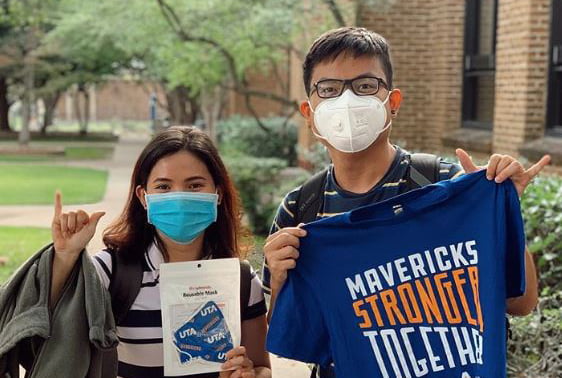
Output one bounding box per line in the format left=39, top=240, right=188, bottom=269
left=51, top=126, right=271, bottom=378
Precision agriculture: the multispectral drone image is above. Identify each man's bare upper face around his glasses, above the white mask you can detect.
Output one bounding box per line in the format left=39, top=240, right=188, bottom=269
left=301, top=54, right=401, bottom=148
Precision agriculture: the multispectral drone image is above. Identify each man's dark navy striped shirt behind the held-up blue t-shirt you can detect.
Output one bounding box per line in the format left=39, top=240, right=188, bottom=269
left=262, top=146, right=463, bottom=294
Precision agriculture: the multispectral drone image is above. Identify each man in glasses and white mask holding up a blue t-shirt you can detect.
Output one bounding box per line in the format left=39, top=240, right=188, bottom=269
left=263, top=27, right=550, bottom=377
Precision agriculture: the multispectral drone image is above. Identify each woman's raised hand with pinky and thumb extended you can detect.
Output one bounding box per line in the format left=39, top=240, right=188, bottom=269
left=51, top=191, right=105, bottom=258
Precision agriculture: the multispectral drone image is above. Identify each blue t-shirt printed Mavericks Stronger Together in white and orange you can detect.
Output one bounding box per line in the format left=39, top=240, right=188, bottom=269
left=267, top=171, right=525, bottom=378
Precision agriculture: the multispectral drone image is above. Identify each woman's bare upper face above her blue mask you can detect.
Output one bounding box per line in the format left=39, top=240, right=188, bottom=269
left=136, top=151, right=220, bottom=204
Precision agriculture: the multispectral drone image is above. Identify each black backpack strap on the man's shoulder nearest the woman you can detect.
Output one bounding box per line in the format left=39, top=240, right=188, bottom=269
left=295, top=168, right=329, bottom=225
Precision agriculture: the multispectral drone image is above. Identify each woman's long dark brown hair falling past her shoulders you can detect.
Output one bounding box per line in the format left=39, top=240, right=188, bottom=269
left=103, top=126, right=242, bottom=259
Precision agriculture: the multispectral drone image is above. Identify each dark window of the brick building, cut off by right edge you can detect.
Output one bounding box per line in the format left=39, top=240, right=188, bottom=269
left=546, top=0, right=562, bottom=136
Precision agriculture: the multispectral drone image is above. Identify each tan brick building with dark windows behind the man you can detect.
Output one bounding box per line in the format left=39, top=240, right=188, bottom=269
left=231, top=0, right=562, bottom=167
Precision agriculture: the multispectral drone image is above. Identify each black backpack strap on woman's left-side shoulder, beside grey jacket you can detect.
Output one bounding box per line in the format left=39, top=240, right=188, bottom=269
left=109, top=251, right=143, bottom=325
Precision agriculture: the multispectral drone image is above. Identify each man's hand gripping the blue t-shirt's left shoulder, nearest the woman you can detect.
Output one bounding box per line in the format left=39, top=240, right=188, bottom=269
left=263, top=225, right=306, bottom=293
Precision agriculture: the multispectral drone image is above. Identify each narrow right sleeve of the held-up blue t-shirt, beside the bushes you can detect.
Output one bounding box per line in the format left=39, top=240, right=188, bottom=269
left=505, top=180, right=526, bottom=298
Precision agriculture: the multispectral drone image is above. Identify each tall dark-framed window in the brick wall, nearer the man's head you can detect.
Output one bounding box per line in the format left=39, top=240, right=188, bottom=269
left=462, top=0, right=498, bottom=130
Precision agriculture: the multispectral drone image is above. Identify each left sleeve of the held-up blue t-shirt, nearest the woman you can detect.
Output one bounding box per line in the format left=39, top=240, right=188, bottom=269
left=267, top=272, right=332, bottom=366
